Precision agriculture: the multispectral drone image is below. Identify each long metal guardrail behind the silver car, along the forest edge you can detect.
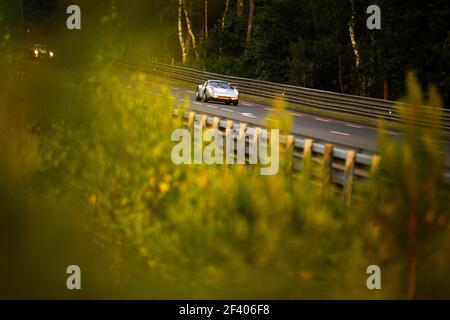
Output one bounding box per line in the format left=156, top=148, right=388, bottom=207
left=122, top=57, right=450, bottom=132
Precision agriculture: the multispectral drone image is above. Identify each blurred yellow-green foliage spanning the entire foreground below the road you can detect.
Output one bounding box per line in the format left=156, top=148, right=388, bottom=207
left=0, top=37, right=450, bottom=299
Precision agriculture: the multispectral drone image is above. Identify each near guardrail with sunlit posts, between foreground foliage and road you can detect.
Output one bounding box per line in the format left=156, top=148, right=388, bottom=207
left=173, top=108, right=380, bottom=202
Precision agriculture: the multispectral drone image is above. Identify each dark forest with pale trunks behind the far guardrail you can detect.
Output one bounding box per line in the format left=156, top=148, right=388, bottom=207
left=0, top=0, right=450, bottom=107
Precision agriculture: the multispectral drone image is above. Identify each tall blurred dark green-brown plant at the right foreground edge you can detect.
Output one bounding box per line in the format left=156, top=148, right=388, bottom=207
left=370, top=74, right=450, bottom=298
